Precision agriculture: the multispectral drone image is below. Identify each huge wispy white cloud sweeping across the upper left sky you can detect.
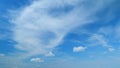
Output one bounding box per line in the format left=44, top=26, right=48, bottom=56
left=12, top=0, right=114, bottom=56
